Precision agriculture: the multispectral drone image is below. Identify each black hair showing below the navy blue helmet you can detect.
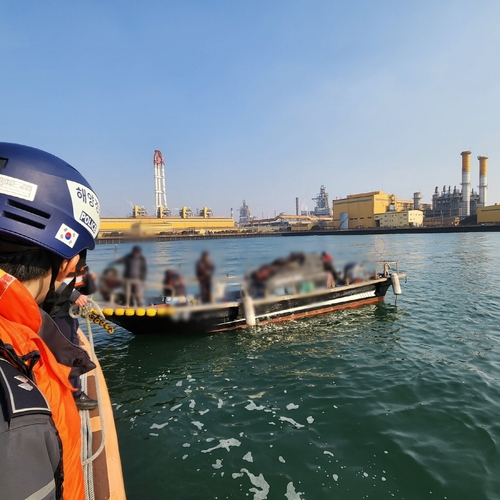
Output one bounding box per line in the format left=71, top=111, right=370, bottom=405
left=0, top=247, right=58, bottom=282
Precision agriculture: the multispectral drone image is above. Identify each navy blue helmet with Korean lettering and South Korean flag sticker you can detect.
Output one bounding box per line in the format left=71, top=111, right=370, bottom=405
left=0, top=142, right=100, bottom=259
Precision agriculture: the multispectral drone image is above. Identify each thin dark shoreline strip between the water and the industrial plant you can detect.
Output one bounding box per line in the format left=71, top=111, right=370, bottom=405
left=96, top=224, right=500, bottom=245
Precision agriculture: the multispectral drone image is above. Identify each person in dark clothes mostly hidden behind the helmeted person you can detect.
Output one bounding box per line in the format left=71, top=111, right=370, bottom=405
left=49, top=254, right=98, bottom=410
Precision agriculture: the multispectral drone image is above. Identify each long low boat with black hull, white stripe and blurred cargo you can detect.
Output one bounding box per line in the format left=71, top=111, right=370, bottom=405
left=96, top=256, right=406, bottom=335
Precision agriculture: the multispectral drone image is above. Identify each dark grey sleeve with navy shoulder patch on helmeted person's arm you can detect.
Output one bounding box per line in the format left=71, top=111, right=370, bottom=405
left=0, top=358, right=63, bottom=500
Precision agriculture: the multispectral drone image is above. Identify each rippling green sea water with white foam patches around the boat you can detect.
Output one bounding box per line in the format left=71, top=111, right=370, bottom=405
left=88, top=233, right=500, bottom=500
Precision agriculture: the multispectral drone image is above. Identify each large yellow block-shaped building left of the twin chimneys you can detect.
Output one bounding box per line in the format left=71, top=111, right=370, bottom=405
left=333, top=191, right=421, bottom=229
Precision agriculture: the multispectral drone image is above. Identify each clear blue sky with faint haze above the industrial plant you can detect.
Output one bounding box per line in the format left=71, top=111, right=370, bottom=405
left=0, top=0, right=500, bottom=217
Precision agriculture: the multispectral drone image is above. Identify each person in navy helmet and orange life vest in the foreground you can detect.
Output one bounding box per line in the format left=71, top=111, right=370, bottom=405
left=0, top=142, right=100, bottom=500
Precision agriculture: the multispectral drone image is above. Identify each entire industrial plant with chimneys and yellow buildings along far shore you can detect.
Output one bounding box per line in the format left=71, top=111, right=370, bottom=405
left=99, top=150, right=500, bottom=237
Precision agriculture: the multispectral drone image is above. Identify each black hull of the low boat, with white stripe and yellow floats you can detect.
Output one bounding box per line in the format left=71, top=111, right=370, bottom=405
left=99, top=278, right=391, bottom=335
